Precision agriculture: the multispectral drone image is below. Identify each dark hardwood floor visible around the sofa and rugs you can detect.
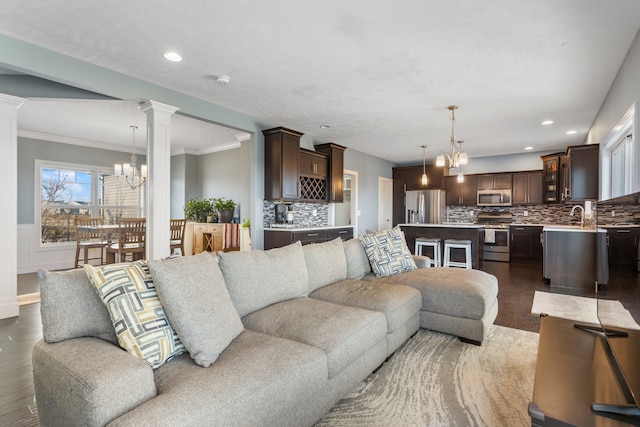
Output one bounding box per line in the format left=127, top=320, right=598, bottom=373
left=0, top=261, right=640, bottom=426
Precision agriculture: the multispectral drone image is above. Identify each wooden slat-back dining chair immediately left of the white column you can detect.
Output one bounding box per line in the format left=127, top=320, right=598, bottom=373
left=106, top=218, right=147, bottom=264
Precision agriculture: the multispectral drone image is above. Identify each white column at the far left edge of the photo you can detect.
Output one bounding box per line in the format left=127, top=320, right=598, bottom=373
left=0, top=94, right=25, bottom=319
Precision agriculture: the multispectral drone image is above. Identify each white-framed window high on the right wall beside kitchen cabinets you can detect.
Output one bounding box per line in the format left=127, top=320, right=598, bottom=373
left=601, top=103, right=640, bottom=200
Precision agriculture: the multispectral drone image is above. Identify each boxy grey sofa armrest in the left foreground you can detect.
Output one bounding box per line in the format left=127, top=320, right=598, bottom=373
left=32, top=338, right=157, bottom=426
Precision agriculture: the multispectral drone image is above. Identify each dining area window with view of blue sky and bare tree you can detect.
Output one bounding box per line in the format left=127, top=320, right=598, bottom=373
left=36, top=160, right=144, bottom=245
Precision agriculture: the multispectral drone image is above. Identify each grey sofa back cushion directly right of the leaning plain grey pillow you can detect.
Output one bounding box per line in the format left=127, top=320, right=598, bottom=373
left=218, top=242, right=309, bottom=317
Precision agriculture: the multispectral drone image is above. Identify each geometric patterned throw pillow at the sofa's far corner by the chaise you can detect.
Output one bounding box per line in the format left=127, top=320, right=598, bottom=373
left=360, top=227, right=417, bottom=277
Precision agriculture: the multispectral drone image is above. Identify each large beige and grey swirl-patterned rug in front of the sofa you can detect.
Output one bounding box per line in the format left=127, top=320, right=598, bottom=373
left=316, top=325, right=538, bottom=427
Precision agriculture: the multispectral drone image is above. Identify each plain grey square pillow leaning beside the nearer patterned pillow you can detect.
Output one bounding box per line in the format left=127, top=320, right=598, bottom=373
left=149, top=252, right=244, bottom=368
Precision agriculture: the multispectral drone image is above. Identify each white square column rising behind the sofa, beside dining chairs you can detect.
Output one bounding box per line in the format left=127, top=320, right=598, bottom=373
left=140, top=101, right=178, bottom=259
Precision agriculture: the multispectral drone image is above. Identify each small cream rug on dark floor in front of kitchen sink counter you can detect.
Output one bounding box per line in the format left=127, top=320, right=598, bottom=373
left=531, top=291, right=640, bottom=329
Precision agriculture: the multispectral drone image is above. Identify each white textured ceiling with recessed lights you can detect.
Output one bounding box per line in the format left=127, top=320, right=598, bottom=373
left=0, top=0, right=640, bottom=163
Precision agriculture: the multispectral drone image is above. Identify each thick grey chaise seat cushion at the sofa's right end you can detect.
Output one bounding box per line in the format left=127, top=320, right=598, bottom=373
left=364, top=267, right=498, bottom=319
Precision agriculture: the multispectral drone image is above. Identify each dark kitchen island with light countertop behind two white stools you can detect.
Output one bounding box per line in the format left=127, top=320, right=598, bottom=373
left=398, top=223, right=484, bottom=269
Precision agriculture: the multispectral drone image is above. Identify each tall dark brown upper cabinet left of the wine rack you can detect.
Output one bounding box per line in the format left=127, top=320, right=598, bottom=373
left=262, top=127, right=303, bottom=201
